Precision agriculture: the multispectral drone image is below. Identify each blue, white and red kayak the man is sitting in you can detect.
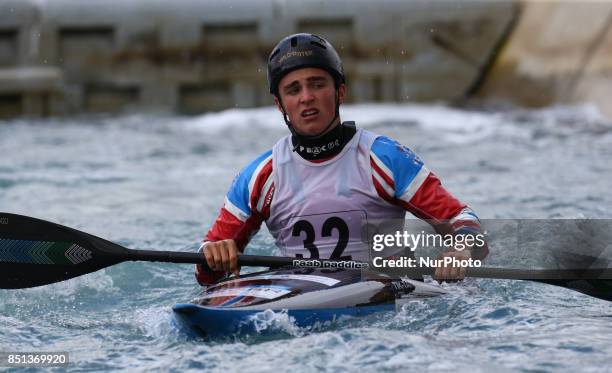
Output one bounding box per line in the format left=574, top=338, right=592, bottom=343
left=172, top=268, right=446, bottom=338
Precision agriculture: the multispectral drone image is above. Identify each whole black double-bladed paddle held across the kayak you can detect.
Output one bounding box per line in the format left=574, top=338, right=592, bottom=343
left=0, top=213, right=612, bottom=301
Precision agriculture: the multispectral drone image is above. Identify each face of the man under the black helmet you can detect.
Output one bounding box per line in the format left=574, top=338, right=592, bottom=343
left=274, top=67, right=346, bottom=136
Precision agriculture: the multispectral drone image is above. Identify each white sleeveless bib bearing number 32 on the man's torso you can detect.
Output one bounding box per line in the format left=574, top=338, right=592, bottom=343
left=266, top=129, right=405, bottom=260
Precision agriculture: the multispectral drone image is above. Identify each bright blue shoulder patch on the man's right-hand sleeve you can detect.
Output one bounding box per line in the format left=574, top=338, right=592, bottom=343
left=372, top=136, right=423, bottom=198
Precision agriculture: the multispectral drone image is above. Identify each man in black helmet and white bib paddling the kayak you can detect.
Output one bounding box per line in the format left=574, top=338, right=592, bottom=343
left=196, top=34, right=487, bottom=285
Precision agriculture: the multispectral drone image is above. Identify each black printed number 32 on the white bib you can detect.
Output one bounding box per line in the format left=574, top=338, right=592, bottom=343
left=292, top=216, right=350, bottom=259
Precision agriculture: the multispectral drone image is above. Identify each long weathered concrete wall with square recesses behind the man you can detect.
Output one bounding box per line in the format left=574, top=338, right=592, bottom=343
left=0, top=0, right=517, bottom=117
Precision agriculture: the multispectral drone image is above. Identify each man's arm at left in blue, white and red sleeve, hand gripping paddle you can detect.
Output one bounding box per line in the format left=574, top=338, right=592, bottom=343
left=196, top=151, right=274, bottom=285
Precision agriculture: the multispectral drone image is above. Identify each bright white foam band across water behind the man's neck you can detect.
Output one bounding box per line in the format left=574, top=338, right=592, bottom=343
left=180, top=104, right=612, bottom=147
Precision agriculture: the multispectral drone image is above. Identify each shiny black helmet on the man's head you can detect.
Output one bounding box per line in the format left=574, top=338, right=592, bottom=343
left=268, top=34, right=345, bottom=95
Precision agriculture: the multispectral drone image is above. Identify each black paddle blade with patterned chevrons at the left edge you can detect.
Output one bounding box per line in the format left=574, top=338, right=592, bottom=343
left=0, top=213, right=129, bottom=289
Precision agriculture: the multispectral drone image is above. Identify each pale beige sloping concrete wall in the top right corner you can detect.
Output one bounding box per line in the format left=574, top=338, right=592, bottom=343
left=478, top=1, right=612, bottom=118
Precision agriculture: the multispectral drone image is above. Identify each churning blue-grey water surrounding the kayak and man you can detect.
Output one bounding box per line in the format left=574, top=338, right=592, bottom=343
left=0, top=105, right=612, bottom=372
